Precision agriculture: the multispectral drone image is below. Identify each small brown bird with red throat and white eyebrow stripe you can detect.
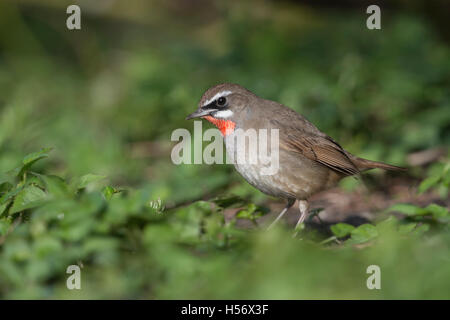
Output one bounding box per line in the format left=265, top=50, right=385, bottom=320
left=186, top=83, right=405, bottom=227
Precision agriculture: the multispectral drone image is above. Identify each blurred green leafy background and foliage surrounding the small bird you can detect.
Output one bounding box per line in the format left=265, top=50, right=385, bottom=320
left=0, top=0, right=450, bottom=299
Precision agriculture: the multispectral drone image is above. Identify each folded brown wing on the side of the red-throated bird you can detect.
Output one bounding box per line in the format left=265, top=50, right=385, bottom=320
left=272, top=117, right=360, bottom=175
